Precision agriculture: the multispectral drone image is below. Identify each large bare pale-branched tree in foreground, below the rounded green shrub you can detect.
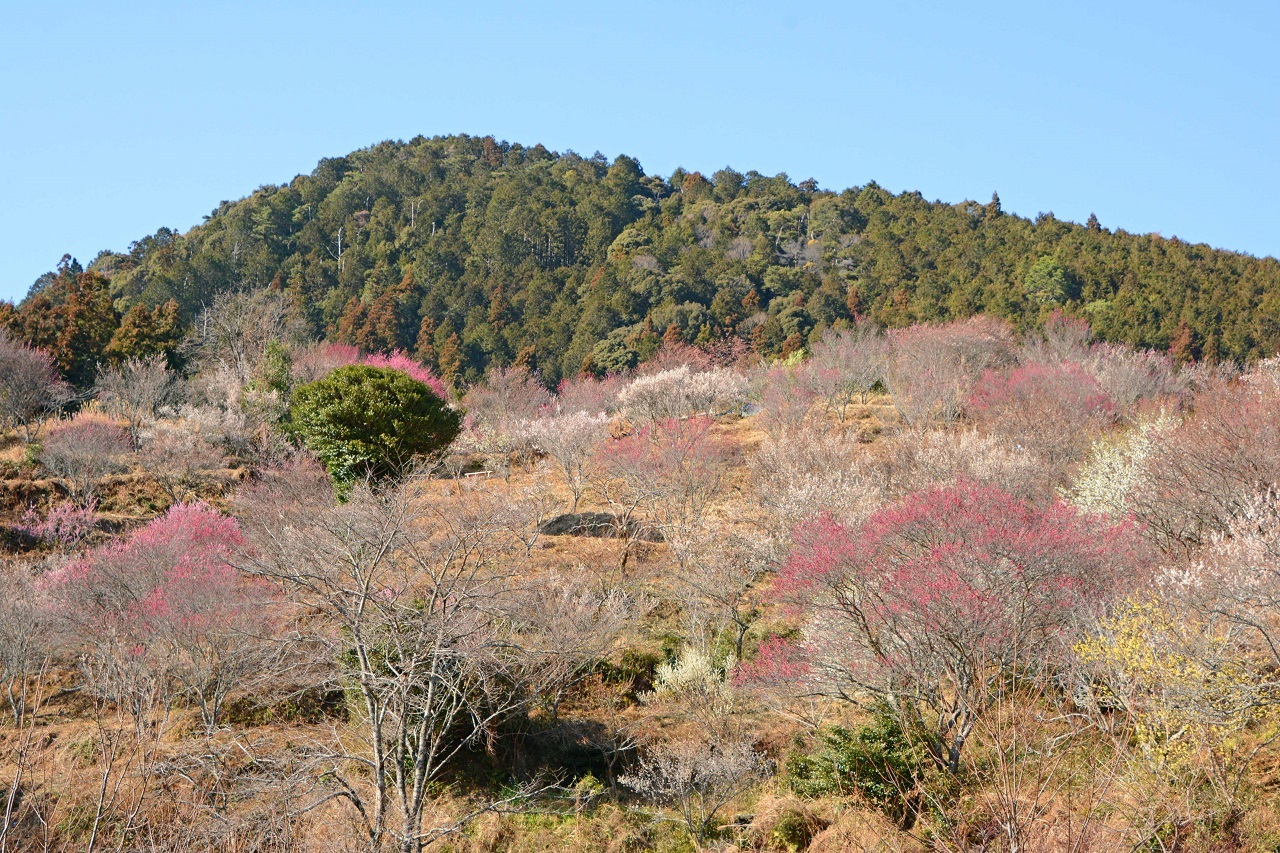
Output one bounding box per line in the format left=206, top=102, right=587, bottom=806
left=239, top=473, right=555, bottom=853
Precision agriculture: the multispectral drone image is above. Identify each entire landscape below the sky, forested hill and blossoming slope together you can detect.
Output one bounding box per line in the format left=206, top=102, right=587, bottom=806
left=0, top=136, right=1280, bottom=853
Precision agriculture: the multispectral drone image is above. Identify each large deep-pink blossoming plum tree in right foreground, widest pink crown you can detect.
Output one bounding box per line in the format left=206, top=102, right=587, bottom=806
left=778, top=483, right=1140, bottom=772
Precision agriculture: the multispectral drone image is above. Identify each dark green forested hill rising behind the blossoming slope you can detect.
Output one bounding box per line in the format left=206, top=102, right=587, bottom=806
left=15, top=136, right=1280, bottom=380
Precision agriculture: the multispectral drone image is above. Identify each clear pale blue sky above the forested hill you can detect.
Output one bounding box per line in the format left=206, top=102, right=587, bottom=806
left=0, top=0, right=1280, bottom=298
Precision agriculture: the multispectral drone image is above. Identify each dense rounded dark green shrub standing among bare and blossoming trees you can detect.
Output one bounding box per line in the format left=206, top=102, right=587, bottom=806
left=289, top=365, right=462, bottom=483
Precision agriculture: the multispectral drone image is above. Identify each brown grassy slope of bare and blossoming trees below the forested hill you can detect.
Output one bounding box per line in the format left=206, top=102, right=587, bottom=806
left=0, top=275, right=1280, bottom=853
